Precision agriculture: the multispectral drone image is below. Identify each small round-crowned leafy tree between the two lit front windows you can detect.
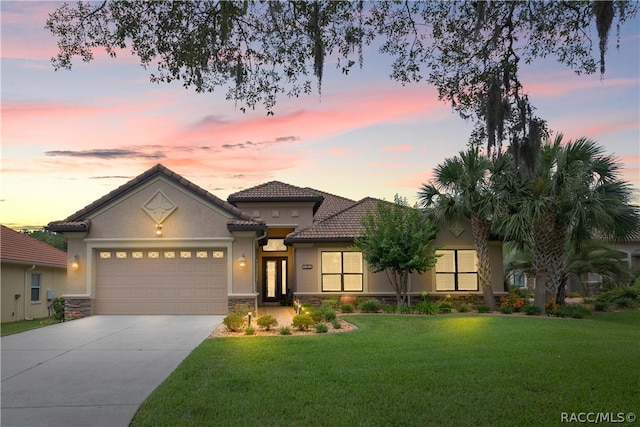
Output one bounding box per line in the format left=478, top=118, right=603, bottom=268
left=354, top=195, right=436, bottom=311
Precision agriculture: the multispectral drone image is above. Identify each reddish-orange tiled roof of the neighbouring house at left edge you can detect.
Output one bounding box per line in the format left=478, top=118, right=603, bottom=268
left=0, top=225, right=67, bottom=268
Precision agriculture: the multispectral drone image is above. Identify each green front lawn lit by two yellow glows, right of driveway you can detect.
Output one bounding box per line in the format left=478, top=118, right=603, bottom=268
left=132, top=311, right=640, bottom=426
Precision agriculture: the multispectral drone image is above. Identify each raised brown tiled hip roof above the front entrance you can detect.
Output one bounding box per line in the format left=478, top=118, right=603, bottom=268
left=227, top=181, right=324, bottom=214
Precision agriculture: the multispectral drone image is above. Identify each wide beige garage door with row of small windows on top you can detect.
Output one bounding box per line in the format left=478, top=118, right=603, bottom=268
left=95, top=248, right=228, bottom=314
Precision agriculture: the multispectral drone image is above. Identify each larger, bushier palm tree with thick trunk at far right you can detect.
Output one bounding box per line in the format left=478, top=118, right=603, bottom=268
left=501, top=134, right=640, bottom=310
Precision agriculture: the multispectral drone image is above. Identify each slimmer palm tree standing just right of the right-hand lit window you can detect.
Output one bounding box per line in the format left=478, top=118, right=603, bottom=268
left=418, top=145, right=496, bottom=309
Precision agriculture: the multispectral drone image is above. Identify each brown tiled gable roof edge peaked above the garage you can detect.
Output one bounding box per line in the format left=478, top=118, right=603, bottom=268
left=47, top=164, right=266, bottom=232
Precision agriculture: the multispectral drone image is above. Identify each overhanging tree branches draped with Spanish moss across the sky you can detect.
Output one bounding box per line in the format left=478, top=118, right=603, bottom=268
left=46, top=0, right=638, bottom=160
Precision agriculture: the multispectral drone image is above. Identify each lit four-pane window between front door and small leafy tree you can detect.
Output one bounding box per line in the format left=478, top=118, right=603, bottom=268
left=321, top=251, right=363, bottom=292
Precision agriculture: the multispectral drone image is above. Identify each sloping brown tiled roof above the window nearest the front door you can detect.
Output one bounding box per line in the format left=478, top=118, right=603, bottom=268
left=284, top=197, right=380, bottom=244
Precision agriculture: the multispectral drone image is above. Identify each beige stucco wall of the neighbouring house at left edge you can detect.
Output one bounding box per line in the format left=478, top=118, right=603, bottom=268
left=0, top=262, right=66, bottom=322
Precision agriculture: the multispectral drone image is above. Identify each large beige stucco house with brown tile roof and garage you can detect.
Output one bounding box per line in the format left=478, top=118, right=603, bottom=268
left=48, top=165, right=503, bottom=315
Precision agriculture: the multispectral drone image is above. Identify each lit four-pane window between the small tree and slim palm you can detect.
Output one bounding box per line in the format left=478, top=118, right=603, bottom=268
left=436, top=249, right=478, bottom=292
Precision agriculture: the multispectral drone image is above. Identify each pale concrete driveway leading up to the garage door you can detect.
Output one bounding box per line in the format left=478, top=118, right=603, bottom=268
left=0, top=316, right=224, bottom=427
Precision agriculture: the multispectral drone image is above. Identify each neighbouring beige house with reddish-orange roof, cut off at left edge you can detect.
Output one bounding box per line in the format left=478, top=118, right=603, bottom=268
left=0, top=225, right=68, bottom=322
